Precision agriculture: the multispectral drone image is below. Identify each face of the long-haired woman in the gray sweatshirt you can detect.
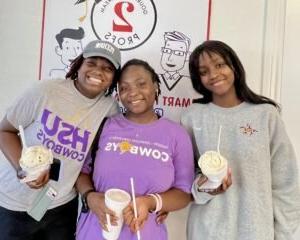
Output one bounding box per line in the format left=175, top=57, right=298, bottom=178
left=199, top=52, right=239, bottom=105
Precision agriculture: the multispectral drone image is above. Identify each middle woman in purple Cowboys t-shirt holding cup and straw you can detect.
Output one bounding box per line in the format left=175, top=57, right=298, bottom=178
left=76, top=59, right=194, bottom=240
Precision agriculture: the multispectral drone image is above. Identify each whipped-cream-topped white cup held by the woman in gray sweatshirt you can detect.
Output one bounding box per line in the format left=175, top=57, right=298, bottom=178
left=198, top=151, right=228, bottom=189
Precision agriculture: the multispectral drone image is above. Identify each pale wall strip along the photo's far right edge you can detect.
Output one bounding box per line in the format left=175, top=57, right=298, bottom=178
left=281, top=0, right=300, bottom=236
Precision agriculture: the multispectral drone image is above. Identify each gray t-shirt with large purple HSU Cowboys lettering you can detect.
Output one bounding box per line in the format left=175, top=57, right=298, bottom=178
left=0, top=79, right=118, bottom=211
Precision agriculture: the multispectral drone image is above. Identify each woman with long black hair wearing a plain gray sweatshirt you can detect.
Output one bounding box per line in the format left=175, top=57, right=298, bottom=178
left=181, top=41, right=300, bottom=240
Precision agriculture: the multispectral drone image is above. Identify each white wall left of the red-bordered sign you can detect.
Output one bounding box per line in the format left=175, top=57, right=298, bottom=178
left=0, top=0, right=43, bottom=119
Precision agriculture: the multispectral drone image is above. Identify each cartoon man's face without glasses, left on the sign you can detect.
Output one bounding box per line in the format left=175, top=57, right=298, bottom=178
left=55, top=38, right=82, bottom=66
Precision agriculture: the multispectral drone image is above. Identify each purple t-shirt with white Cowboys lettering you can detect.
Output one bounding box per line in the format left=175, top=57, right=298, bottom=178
left=76, top=114, right=194, bottom=240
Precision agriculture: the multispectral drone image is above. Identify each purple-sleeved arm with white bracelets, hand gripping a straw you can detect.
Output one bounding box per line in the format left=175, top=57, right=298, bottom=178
left=125, top=124, right=194, bottom=231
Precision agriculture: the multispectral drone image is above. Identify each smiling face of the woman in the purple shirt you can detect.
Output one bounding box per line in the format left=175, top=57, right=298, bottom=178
left=119, top=65, right=157, bottom=122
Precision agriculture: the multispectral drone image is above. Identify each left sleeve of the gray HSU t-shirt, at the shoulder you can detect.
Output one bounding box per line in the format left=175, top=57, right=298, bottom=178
left=6, top=83, right=45, bottom=129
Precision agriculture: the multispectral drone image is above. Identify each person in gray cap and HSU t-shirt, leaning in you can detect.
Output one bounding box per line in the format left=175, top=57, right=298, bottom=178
left=0, top=40, right=121, bottom=240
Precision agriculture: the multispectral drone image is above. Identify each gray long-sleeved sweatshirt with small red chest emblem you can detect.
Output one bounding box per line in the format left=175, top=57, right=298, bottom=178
left=182, top=102, right=300, bottom=240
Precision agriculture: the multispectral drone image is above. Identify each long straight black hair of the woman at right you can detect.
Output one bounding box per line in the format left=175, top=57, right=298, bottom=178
left=189, top=40, right=280, bottom=110
